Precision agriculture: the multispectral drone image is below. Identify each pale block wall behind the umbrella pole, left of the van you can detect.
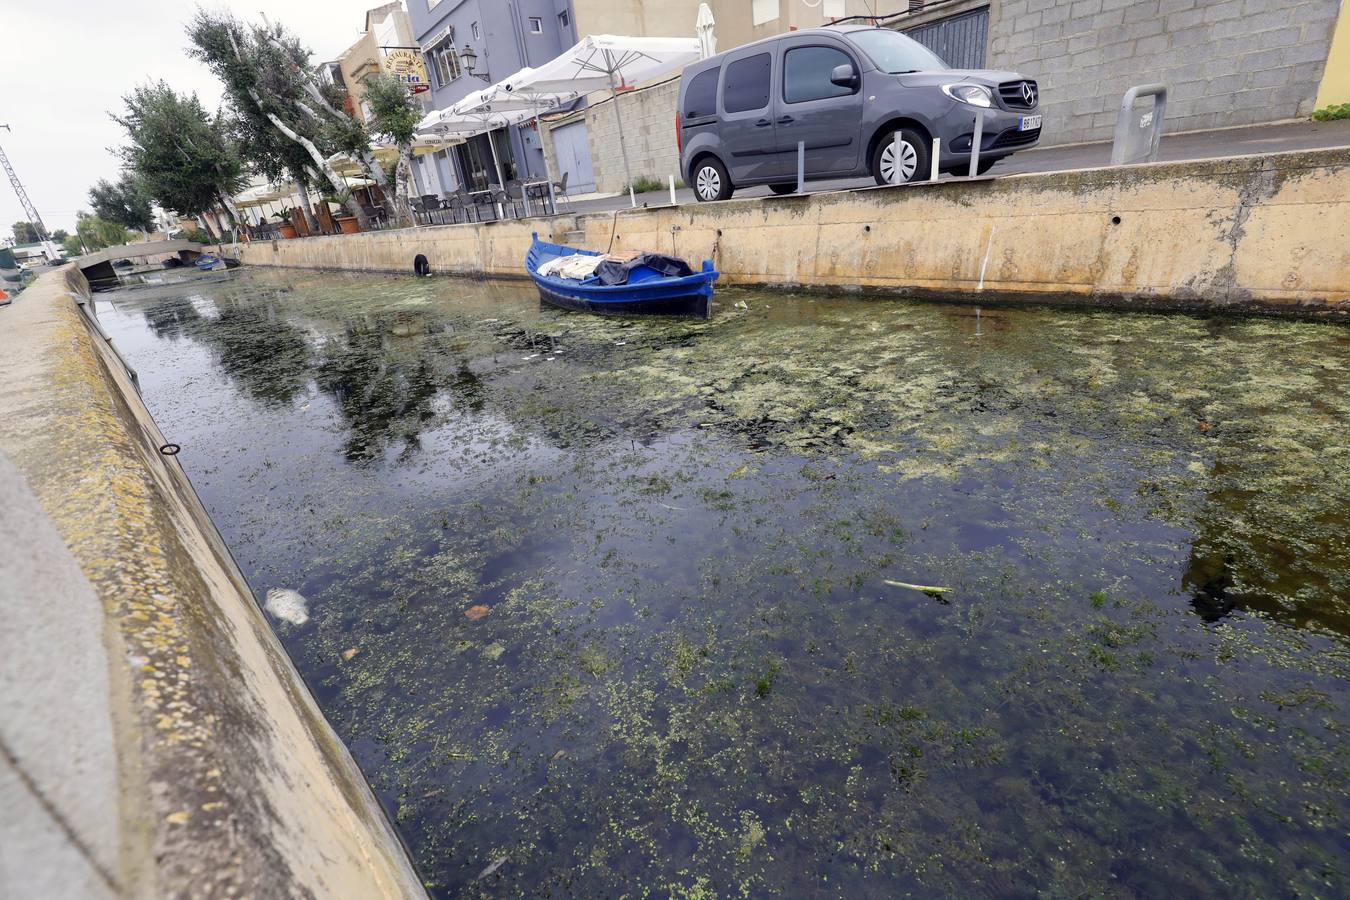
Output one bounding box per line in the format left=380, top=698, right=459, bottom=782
left=543, top=77, right=680, bottom=193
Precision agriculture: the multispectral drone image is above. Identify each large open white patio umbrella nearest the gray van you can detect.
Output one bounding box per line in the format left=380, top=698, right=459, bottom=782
left=504, top=34, right=699, bottom=205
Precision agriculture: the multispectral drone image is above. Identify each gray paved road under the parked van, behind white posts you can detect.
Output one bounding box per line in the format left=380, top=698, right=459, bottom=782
left=562, top=120, right=1350, bottom=212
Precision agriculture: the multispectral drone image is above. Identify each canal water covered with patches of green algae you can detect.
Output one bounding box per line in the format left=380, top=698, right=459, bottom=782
left=99, top=270, right=1350, bottom=899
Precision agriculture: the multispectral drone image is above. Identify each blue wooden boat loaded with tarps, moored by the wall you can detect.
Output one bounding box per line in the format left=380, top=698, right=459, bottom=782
left=525, top=233, right=718, bottom=318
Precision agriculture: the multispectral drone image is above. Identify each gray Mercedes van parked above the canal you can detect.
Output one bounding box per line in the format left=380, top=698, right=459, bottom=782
left=675, top=26, right=1041, bottom=201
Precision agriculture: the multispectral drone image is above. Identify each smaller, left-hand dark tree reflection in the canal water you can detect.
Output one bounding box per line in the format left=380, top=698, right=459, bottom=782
left=193, top=298, right=311, bottom=406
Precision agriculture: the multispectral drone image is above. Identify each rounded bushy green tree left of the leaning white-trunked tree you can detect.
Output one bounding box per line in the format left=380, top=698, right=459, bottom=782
left=113, top=81, right=246, bottom=232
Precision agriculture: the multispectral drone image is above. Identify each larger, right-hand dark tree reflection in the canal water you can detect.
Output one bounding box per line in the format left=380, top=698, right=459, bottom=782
left=317, top=312, right=472, bottom=461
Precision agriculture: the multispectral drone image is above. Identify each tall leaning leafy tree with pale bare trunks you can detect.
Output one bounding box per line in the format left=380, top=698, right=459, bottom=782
left=188, top=8, right=387, bottom=224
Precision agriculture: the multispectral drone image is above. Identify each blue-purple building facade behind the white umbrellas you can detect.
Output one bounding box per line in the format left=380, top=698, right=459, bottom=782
left=408, top=0, right=576, bottom=193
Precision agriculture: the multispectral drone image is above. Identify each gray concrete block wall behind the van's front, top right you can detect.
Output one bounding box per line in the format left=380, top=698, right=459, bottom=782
left=987, top=0, right=1339, bottom=146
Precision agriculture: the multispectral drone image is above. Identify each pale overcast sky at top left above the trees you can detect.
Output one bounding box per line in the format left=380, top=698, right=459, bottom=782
left=0, top=0, right=381, bottom=237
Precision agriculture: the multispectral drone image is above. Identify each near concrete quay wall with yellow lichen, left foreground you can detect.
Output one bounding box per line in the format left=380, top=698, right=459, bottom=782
left=0, top=264, right=425, bottom=899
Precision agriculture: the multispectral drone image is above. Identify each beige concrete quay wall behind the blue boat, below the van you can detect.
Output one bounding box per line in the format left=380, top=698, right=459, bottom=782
left=227, top=148, right=1350, bottom=316
